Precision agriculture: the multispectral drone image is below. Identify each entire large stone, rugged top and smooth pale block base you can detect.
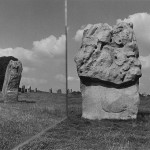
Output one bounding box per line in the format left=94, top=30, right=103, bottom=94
left=75, top=22, right=142, bottom=120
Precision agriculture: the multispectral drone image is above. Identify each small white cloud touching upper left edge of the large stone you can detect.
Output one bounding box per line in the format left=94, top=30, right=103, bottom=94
left=74, top=24, right=92, bottom=42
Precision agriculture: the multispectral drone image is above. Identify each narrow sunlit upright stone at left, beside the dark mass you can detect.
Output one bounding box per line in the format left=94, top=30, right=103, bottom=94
left=2, top=60, right=22, bottom=102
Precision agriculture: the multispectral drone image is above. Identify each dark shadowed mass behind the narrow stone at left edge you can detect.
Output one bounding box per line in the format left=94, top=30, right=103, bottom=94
left=0, top=56, right=18, bottom=91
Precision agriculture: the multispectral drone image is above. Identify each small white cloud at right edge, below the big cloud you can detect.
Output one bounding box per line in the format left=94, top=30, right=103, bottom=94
left=139, top=55, right=150, bottom=69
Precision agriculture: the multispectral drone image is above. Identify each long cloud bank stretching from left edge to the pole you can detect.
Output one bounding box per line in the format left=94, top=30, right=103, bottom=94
left=0, top=35, right=66, bottom=62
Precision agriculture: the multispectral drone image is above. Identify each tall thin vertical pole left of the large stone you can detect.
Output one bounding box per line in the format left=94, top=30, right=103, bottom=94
left=65, top=0, right=68, bottom=117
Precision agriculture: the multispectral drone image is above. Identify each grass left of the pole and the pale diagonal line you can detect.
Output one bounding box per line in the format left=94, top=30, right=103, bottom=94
left=0, top=93, right=65, bottom=150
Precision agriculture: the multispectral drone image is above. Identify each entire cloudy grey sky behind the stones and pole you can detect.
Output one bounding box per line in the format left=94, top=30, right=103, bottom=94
left=0, top=0, right=150, bottom=94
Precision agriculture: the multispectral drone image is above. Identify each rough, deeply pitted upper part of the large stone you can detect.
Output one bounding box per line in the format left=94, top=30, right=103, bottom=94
left=75, top=22, right=142, bottom=84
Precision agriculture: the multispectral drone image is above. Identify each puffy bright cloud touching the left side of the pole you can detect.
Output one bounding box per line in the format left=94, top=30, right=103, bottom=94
left=33, top=35, right=66, bottom=57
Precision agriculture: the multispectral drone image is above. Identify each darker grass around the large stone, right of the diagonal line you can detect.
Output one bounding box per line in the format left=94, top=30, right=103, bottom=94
left=15, top=96, right=150, bottom=150
